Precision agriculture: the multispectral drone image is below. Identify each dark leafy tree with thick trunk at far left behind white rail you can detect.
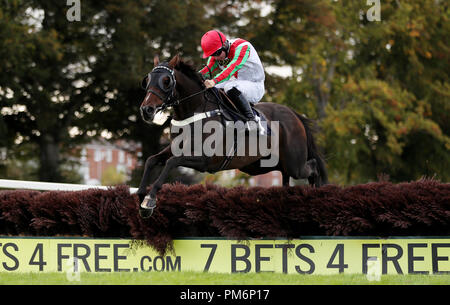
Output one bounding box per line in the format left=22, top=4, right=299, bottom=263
left=0, top=1, right=104, bottom=181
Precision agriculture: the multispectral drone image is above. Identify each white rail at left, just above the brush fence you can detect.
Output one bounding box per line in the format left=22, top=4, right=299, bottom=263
left=0, top=179, right=137, bottom=193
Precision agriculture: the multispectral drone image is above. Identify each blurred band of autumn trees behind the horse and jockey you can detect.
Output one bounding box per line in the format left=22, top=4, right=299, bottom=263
left=0, top=0, right=450, bottom=184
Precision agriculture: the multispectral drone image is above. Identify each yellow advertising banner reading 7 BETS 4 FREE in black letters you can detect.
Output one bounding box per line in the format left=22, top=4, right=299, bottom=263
left=0, top=237, right=450, bottom=275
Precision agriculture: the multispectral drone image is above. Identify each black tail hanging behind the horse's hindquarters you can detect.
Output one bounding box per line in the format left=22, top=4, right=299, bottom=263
left=294, top=111, right=328, bottom=185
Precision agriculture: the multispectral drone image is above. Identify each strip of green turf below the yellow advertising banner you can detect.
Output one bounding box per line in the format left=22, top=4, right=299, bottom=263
left=0, top=272, right=450, bottom=285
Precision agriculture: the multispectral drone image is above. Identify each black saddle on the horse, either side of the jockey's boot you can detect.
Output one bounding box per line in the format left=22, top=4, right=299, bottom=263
left=212, top=88, right=270, bottom=135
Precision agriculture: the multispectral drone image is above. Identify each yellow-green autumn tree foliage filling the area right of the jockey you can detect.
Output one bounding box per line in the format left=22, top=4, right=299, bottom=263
left=244, top=1, right=450, bottom=183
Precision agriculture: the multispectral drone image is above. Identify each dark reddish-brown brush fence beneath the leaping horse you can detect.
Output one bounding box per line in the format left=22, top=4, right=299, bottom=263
left=0, top=180, right=450, bottom=253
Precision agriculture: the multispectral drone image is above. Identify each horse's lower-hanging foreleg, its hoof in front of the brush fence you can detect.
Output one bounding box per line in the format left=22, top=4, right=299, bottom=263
left=141, top=156, right=206, bottom=217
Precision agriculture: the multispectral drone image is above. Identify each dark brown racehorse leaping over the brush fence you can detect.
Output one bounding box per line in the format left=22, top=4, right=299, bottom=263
left=137, top=55, right=328, bottom=218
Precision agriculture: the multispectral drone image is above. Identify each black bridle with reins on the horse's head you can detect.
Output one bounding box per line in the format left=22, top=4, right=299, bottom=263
left=142, top=65, right=208, bottom=112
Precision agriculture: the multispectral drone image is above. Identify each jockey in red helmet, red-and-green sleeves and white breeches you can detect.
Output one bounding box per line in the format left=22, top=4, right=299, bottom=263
left=200, top=30, right=265, bottom=125
